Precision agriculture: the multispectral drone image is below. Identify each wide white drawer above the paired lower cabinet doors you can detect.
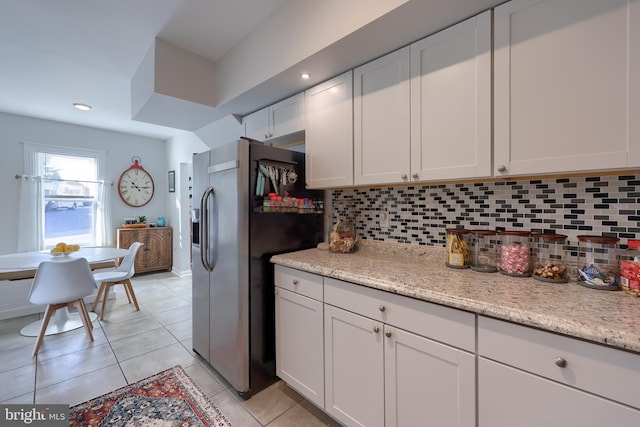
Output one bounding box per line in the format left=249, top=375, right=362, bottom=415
left=324, top=277, right=475, bottom=352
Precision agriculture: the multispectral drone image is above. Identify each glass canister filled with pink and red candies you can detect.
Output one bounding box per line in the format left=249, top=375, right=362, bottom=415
left=500, top=231, right=531, bottom=277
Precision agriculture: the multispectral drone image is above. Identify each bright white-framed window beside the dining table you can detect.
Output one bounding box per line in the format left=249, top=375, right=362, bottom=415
left=21, top=144, right=110, bottom=249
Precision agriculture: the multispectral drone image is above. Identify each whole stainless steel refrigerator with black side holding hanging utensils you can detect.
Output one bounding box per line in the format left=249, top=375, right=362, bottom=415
left=191, top=139, right=324, bottom=398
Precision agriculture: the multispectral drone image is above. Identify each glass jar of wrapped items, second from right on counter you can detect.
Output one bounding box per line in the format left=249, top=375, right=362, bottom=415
left=578, top=236, right=620, bottom=291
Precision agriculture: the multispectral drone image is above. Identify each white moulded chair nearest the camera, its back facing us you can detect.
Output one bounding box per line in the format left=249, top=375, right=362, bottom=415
left=29, top=258, right=96, bottom=356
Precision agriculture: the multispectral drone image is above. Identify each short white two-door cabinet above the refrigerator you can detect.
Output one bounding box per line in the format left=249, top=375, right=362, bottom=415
left=242, top=93, right=304, bottom=141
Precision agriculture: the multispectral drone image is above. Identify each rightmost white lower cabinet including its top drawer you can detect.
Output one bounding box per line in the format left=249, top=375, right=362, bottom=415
left=478, top=316, right=640, bottom=427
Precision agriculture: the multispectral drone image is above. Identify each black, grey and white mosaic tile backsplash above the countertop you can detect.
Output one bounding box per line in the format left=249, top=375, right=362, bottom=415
left=331, top=175, right=640, bottom=247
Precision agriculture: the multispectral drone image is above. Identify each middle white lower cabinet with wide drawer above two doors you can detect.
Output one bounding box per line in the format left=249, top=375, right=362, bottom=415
left=324, top=278, right=476, bottom=427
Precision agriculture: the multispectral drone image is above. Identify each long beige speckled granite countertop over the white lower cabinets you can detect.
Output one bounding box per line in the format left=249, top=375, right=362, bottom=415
left=271, top=241, right=640, bottom=353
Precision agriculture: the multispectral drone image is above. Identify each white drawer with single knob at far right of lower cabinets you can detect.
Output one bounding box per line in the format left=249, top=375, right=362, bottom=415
left=478, top=316, right=640, bottom=408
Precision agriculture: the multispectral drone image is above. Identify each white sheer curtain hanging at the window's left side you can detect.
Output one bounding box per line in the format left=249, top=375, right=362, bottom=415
left=18, top=176, right=44, bottom=252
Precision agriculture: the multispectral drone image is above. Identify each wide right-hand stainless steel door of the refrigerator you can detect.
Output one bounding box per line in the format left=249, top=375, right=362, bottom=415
left=207, top=141, right=249, bottom=392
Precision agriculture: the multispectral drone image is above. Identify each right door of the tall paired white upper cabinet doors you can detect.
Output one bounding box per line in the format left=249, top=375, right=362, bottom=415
left=411, top=11, right=491, bottom=181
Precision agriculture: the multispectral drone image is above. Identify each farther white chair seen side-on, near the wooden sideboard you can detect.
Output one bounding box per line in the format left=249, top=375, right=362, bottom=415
left=91, top=242, right=143, bottom=320
